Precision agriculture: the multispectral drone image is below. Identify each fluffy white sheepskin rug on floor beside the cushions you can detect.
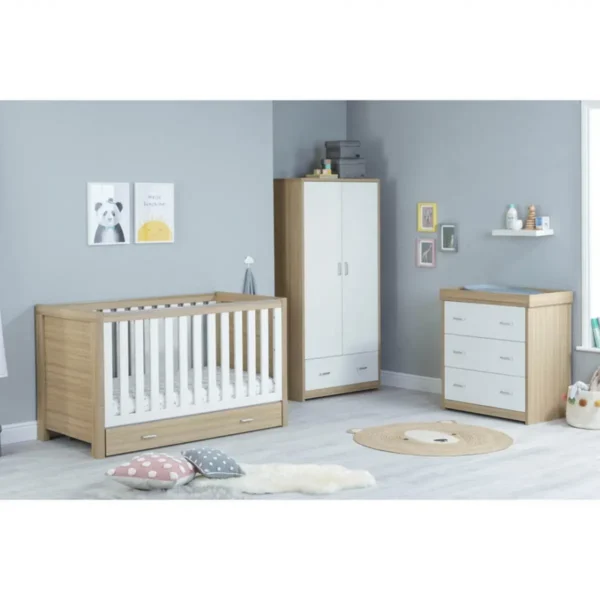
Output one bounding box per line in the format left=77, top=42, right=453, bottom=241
left=196, top=464, right=375, bottom=494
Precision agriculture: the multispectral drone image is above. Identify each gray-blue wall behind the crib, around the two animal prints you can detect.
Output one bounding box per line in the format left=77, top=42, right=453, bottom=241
left=0, top=102, right=274, bottom=424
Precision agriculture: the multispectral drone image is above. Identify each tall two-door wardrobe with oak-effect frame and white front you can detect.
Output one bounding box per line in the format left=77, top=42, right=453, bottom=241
left=275, top=179, right=381, bottom=401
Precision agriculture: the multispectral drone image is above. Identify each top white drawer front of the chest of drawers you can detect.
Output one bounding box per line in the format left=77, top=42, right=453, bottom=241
left=444, top=302, right=525, bottom=342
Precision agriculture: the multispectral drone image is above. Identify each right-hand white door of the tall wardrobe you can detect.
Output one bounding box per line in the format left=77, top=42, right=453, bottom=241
left=342, top=182, right=379, bottom=354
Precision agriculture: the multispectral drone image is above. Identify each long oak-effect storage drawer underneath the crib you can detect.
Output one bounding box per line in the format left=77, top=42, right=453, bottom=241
left=106, top=402, right=283, bottom=456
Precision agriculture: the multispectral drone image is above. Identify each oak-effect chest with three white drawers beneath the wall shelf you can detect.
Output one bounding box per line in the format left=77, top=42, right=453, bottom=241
left=440, top=288, right=573, bottom=424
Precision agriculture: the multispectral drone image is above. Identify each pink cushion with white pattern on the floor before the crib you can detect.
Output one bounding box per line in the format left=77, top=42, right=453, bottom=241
left=106, top=452, right=195, bottom=490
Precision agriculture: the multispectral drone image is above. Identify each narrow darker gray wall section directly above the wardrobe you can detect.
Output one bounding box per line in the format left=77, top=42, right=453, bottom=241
left=273, top=100, right=347, bottom=177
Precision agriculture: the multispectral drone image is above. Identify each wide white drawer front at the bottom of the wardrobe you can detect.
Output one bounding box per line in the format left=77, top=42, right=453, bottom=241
left=304, top=352, right=379, bottom=391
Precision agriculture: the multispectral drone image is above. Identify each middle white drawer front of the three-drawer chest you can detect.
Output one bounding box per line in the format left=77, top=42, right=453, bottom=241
left=444, top=334, right=525, bottom=377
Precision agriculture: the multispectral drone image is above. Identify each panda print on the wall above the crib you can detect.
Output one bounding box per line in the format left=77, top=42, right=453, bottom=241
left=87, top=183, right=131, bottom=246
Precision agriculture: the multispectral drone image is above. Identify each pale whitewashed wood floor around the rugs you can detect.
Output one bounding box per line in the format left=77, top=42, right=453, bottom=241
left=0, top=388, right=600, bottom=499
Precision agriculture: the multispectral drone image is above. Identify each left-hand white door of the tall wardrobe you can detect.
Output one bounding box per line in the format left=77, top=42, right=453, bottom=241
left=304, top=182, right=342, bottom=359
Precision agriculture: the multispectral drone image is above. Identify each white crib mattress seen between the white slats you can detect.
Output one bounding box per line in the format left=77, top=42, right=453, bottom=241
left=113, top=367, right=275, bottom=415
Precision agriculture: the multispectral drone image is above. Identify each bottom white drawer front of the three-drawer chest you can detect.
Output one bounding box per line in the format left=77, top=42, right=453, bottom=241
left=444, top=367, right=525, bottom=412
